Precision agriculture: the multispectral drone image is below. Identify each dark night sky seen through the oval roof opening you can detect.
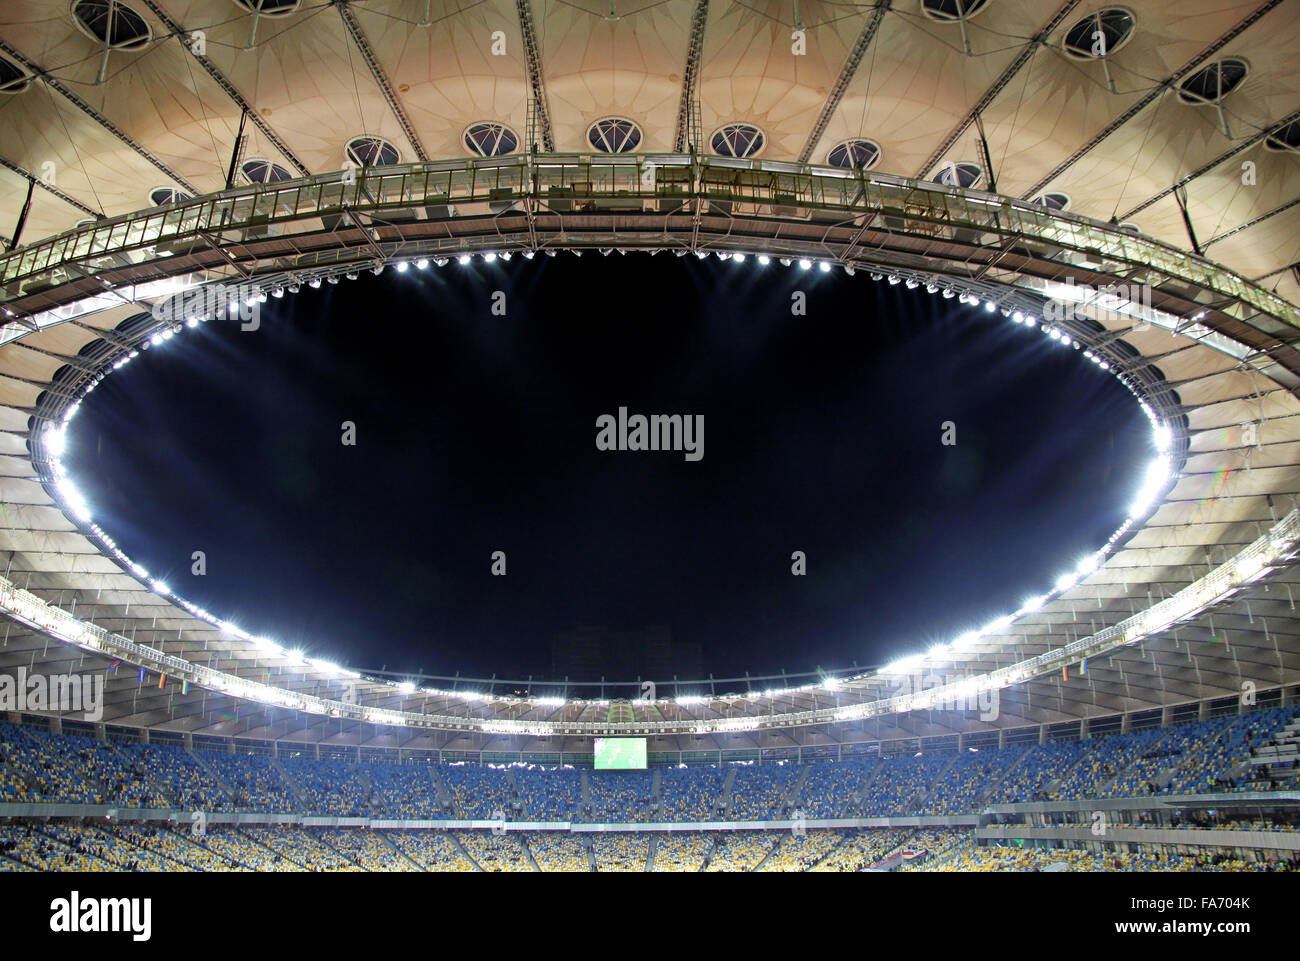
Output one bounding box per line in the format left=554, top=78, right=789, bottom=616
left=65, top=252, right=1152, bottom=678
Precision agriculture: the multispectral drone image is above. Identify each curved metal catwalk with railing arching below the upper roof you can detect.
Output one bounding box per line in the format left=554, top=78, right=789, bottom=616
left=0, top=153, right=1300, bottom=336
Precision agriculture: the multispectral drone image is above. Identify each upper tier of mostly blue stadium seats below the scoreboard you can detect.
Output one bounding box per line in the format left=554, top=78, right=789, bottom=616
left=0, top=706, right=1297, bottom=823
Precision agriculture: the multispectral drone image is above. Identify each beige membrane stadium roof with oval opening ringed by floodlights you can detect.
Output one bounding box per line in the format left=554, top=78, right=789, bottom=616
left=0, top=0, right=1300, bottom=749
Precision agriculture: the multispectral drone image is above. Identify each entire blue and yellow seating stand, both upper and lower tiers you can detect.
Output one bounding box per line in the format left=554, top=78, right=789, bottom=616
left=0, top=706, right=1300, bottom=871
